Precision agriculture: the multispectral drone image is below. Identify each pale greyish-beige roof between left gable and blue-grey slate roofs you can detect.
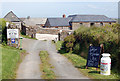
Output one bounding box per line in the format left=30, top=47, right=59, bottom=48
left=23, top=18, right=47, bottom=26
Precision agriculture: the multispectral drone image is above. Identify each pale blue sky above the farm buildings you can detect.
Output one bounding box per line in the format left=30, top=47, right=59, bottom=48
left=0, top=0, right=118, bottom=18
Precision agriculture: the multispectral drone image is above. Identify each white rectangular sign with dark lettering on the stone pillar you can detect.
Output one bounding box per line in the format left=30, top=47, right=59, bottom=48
left=7, top=29, right=19, bottom=38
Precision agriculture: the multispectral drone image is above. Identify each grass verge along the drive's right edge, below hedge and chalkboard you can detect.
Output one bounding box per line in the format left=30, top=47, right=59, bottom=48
left=56, top=41, right=120, bottom=79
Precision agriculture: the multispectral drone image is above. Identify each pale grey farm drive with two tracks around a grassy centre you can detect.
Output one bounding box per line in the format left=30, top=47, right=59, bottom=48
left=16, top=38, right=89, bottom=79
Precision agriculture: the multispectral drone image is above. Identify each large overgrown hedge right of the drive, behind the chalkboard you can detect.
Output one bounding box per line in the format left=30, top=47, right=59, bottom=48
left=55, top=24, right=120, bottom=78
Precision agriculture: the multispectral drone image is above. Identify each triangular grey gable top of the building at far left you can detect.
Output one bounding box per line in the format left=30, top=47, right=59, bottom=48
left=4, top=11, right=21, bottom=22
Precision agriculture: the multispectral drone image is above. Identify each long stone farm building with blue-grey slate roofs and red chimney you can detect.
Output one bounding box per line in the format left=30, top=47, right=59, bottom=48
left=45, top=15, right=116, bottom=30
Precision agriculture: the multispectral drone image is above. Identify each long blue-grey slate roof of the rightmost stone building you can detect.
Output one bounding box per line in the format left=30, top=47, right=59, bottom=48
left=68, top=15, right=116, bottom=22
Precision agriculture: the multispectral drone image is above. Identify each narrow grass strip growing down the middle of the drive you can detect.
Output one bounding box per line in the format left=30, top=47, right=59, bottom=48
left=40, top=51, right=56, bottom=79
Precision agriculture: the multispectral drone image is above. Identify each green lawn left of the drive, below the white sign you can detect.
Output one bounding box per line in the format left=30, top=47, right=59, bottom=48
left=0, top=46, right=25, bottom=79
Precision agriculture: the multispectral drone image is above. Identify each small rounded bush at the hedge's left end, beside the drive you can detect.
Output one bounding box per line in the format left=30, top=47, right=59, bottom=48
left=64, top=34, right=75, bottom=52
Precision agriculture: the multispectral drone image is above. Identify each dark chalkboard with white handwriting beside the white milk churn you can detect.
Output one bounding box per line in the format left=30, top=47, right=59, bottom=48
left=86, top=46, right=101, bottom=68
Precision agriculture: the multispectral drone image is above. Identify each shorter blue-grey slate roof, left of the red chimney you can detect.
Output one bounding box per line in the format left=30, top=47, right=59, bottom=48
left=47, top=17, right=72, bottom=26
